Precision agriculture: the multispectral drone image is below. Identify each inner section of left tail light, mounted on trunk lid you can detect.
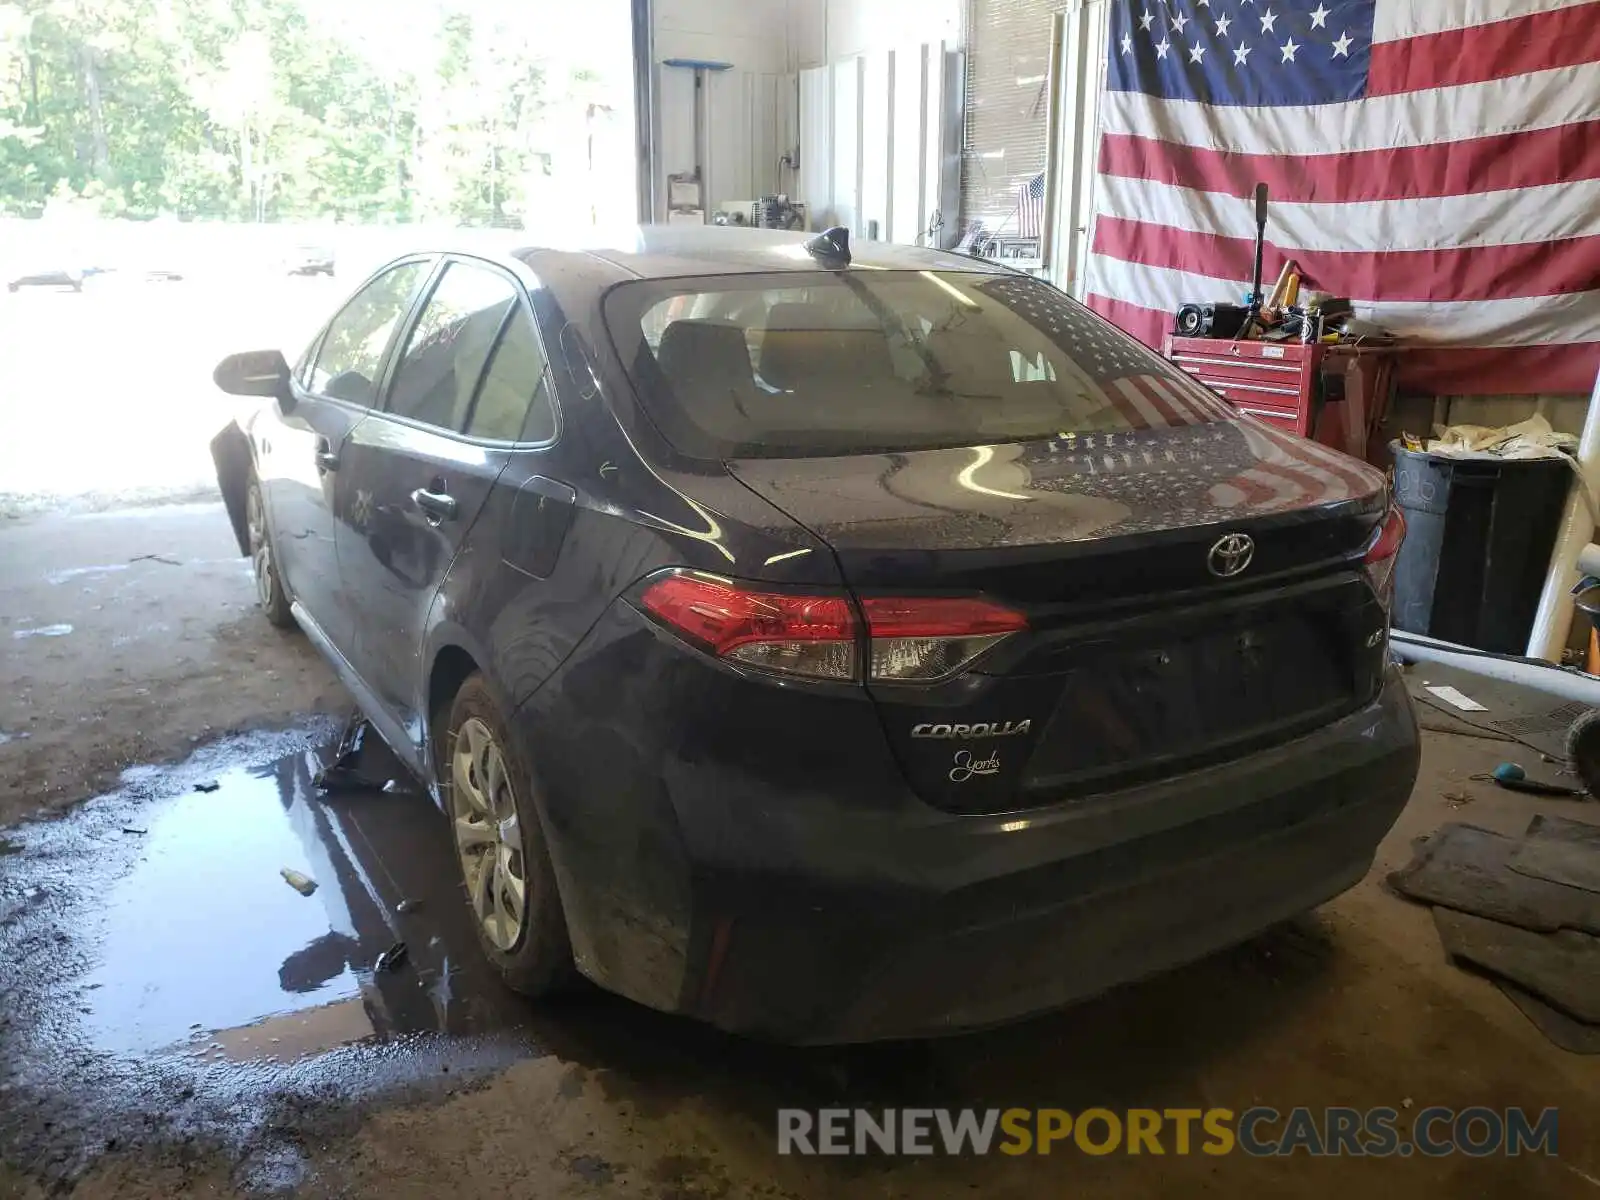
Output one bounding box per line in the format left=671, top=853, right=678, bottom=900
left=861, top=595, right=1027, bottom=683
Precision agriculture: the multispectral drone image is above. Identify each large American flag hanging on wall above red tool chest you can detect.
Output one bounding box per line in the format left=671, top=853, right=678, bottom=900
left=1086, top=0, right=1600, bottom=395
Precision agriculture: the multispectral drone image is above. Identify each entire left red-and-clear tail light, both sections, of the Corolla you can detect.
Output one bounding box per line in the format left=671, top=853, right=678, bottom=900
left=640, top=573, right=1027, bottom=683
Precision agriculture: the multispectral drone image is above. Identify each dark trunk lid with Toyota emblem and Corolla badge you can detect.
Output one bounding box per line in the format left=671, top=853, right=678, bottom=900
left=728, top=421, right=1386, bottom=811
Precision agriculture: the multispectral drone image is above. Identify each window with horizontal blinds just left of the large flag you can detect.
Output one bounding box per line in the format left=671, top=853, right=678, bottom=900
left=962, top=0, right=1066, bottom=234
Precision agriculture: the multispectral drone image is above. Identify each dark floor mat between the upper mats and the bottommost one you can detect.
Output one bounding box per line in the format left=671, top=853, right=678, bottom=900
left=1434, top=909, right=1600, bottom=1026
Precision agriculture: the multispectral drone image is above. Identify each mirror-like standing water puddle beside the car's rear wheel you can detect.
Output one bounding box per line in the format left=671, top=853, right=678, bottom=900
left=21, top=723, right=526, bottom=1061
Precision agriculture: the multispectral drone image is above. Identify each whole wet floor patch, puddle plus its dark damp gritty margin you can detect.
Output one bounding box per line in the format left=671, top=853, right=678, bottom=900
left=0, top=722, right=546, bottom=1177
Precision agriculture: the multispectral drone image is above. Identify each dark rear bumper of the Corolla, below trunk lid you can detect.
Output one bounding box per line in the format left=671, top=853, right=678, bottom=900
left=523, top=611, right=1418, bottom=1043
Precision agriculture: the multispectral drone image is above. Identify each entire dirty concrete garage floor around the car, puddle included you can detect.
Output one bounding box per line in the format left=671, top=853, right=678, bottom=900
left=0, top=506, right=1600, bottom=1200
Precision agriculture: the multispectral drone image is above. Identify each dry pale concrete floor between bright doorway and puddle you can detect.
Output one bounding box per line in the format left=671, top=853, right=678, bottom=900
left=0, top=501, right=340, bottom=827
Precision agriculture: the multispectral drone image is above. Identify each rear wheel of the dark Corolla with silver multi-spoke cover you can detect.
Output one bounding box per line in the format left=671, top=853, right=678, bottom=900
left=435, top=672, right=574, bottom=997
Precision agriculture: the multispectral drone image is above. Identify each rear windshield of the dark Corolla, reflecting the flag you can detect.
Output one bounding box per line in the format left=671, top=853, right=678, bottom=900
left=605, top=269, right=1227, bottom=459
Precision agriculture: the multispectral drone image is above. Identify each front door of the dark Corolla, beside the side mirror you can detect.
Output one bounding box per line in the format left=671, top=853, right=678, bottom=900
left=256, top=258, right=434, bottom=658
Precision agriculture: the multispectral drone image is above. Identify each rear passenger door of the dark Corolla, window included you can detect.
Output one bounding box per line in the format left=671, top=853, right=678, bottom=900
left=339, top=258, right=555, bottom=739
